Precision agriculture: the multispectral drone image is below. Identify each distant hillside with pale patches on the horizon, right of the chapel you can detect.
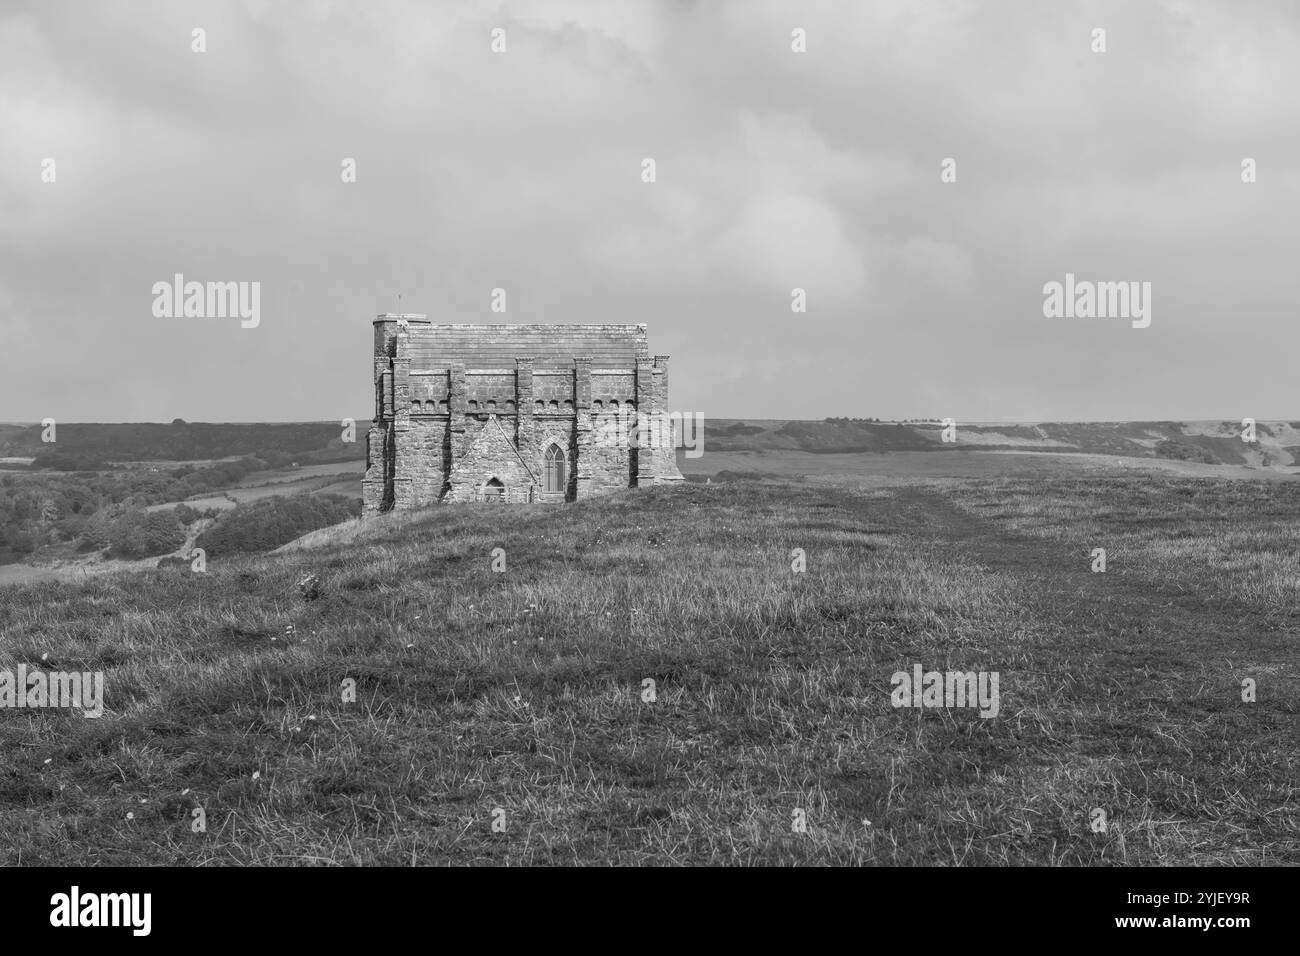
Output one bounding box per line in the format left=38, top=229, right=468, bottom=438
left=705, top=419, right=1300, bottom=468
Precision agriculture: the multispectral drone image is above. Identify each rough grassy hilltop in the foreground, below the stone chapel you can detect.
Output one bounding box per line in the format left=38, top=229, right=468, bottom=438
left=0, top=476, right=1300, bottom=864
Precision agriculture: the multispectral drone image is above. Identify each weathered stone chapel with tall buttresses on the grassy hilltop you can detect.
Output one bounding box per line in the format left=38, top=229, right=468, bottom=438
left=363, top=313, right=683, bottom=515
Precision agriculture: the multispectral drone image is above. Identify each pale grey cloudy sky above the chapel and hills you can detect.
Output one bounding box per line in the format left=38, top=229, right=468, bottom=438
left=0, top=0, right=1300, bottom=421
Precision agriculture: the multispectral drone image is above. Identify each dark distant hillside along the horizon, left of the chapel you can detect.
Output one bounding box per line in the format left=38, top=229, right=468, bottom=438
left=0, top=419, right=369, bottom=462
